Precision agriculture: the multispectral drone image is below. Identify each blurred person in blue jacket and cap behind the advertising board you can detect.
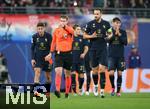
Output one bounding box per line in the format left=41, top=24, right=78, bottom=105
left=128, top=45, right=141, bottom=68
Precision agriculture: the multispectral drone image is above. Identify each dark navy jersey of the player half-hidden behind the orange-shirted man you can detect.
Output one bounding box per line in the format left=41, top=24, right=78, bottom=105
left=72, top=36, right=88, bottom=63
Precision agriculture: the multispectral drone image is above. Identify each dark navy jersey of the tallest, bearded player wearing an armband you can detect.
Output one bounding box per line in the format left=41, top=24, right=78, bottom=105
left=85, top=19, right=110, bottom=50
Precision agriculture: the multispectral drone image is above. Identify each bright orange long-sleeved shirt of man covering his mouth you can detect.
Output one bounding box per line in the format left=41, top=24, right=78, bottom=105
left=51, top=26, right=74, bottom=52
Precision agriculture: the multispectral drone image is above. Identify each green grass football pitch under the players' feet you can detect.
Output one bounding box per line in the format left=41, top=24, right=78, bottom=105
left=50, top=93, right=150, bottom=109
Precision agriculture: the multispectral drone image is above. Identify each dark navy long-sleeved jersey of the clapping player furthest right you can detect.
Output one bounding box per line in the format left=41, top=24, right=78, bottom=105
left=108, top=29, right=127, bottom=57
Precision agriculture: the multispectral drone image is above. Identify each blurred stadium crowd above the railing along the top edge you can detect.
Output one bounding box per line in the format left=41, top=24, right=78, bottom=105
left=0, top=0, right=150, bottom=8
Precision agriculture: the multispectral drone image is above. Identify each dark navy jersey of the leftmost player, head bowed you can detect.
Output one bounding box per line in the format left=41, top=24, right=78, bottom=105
left=31, top=32, right=52, bottom=59
